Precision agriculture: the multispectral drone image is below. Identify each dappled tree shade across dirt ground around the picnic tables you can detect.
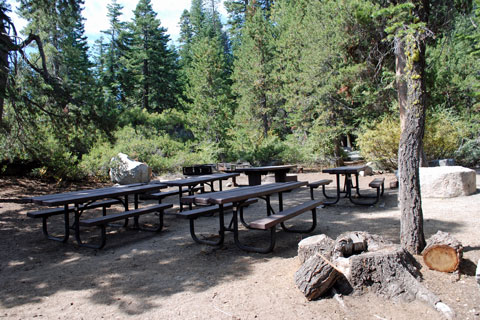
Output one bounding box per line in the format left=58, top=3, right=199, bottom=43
left=0, top=181, right=471, bottom=315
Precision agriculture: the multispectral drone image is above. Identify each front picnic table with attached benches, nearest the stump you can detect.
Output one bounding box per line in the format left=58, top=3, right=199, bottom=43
left=177, top=182, right=322, bottom=253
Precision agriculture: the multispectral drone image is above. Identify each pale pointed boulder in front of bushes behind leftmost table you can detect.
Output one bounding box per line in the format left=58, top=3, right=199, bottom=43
left=110, top=153, right=152, bottom=184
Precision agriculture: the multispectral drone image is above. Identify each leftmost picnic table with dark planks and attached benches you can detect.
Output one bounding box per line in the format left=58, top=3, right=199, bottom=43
left=26, top=184, right=172, bottom=249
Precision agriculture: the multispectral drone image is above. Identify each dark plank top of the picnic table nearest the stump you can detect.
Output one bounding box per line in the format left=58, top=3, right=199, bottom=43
left=189, top=181, right=307, bottom=205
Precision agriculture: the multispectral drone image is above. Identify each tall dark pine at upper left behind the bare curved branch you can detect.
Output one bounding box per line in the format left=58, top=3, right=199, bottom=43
left=20, top=0, right=101, bottom=125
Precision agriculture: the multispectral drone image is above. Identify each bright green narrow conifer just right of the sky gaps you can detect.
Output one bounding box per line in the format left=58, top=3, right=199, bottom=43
left=181, top=0, right=232, bottom=147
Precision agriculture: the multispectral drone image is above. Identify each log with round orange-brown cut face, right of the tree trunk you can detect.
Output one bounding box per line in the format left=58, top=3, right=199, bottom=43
left=422, top=231, right=463, bottom=272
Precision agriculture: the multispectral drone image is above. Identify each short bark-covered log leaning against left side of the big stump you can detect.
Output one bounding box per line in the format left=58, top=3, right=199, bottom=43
left=295, top=253, right=342, bottom=300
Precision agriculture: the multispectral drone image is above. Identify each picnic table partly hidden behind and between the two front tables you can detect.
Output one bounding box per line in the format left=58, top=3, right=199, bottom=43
left=154, top=172, right=240, bottom=211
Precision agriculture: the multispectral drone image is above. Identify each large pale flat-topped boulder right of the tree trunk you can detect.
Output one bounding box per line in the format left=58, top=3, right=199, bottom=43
left=420, top=166, right=477, bottom=198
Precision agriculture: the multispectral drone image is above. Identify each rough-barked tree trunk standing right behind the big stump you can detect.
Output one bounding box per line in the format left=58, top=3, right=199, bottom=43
left=395, top=0, right=428, bottom=254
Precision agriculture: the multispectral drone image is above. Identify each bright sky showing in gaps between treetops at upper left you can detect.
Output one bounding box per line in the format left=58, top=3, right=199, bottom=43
left=7, top=0, right=226, bottom=47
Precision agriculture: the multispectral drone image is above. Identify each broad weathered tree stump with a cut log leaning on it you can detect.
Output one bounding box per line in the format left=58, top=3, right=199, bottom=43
left=295, top=232, right=453, bottom=318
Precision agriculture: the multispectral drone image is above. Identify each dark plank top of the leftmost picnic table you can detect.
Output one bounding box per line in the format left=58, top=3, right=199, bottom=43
left=28, top=183, right=167, bottom=206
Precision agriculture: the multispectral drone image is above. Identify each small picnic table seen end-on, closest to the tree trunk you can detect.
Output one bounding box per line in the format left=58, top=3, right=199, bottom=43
left=309, top=165, right=384, bottom=205
